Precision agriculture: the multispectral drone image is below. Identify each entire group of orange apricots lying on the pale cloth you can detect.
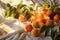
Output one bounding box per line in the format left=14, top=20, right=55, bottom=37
left=19, top=8, right=60, bottom=36
